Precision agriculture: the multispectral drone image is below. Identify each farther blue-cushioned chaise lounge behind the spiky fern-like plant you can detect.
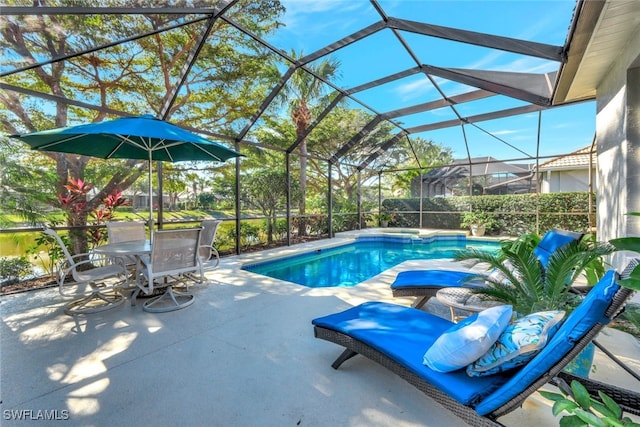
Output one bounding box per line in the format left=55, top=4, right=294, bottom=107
left=391, top=229, right=583, bottom=308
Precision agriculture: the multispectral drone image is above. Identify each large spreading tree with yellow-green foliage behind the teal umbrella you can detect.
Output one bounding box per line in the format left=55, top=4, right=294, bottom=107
left=0, top=0, right=284, bottom=252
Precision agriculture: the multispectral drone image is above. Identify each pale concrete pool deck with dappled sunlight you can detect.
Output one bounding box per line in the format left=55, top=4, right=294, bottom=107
left=0, top=232, right=640, bottom=427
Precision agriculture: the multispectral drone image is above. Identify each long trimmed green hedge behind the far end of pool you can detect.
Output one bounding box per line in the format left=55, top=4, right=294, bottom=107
left=382, top=192, right=595, bottom=236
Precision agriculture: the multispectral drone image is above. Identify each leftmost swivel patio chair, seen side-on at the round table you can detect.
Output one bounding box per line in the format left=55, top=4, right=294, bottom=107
left=44, top=228, right=129, bottom=316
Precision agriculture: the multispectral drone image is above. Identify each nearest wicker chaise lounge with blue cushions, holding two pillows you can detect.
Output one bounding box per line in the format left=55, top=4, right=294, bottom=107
left=312, top=262, right=640, bottom=426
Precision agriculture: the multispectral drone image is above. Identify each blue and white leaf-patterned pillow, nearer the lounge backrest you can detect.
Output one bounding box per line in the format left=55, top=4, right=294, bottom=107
left=467, top=311, right=564, bottom=377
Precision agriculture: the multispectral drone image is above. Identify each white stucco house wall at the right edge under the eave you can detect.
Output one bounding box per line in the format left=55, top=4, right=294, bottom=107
left=596, top=33, right=640, bottom=267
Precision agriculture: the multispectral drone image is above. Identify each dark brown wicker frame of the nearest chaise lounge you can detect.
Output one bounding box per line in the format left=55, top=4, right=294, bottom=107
left=314, top=268, right=640, bottom=426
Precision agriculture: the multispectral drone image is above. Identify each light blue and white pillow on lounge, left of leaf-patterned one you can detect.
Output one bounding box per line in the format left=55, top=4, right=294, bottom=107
left=424, top=305, right=513, bottom=372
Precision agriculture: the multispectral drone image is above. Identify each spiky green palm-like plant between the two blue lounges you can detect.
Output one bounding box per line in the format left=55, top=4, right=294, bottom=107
left=455, top=240, right=613, bottom=315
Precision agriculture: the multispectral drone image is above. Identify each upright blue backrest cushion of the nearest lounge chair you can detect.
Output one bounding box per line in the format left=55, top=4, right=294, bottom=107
left=476, top=270, right=620, bottom=415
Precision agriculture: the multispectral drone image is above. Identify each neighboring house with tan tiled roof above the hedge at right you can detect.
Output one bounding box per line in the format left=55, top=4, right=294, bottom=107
left=538, top=146, right=597, bottom=193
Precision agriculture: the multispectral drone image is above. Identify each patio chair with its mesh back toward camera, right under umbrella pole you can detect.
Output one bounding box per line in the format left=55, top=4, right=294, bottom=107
left=131, top=227, right=203, bottom=313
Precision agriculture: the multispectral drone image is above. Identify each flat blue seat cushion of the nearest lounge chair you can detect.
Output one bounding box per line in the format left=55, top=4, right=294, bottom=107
left=312, top=302, right=508, bottom=405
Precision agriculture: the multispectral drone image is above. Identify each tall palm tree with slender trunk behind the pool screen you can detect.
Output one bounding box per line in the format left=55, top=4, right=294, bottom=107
left=283, top=51, right=340, bottom=235
